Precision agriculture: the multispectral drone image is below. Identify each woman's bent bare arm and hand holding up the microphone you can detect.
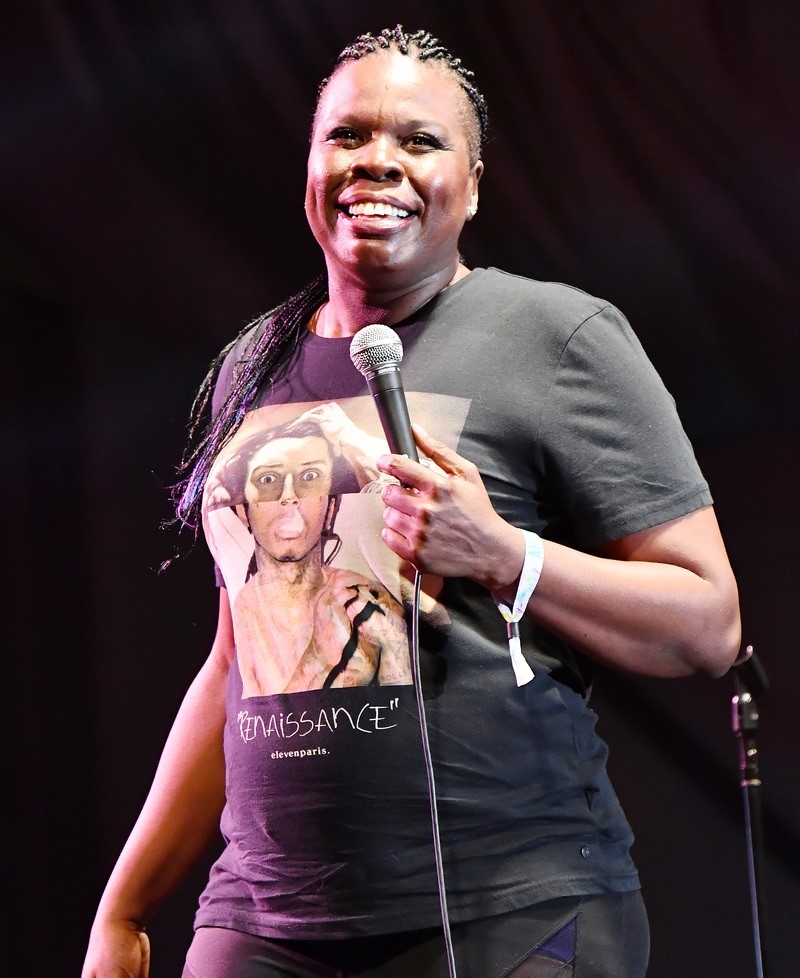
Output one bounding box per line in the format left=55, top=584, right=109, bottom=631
left=378, top=428, right=741, bottom=676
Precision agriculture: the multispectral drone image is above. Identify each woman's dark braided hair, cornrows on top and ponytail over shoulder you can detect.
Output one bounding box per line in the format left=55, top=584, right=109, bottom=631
left=169, top=24, right=489, bottom=536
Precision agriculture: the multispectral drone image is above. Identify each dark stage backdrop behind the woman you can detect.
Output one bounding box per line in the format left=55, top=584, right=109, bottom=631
left=0, top=0, right=800, bottom=978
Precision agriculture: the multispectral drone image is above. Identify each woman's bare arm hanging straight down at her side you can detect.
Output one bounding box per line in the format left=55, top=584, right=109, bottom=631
left=82, top=588, right=234, bottom=978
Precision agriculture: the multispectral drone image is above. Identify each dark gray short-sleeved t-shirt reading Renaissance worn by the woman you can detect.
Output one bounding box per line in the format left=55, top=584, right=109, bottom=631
left=196, top=269, right=711, bottom=938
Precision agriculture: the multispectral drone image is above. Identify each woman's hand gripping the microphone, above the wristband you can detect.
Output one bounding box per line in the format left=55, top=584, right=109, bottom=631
left=378, top=425, right=525, bottom=591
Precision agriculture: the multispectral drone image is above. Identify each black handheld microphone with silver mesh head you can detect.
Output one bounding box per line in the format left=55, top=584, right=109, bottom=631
left=350, top=323, right=419, bottom=462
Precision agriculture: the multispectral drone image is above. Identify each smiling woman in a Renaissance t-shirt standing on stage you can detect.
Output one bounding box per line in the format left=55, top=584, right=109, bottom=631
left=83, top=27, right=740, bottom=978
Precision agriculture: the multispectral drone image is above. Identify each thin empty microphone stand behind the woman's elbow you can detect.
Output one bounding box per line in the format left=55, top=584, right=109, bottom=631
left=732, top=645, right=770, bottom=978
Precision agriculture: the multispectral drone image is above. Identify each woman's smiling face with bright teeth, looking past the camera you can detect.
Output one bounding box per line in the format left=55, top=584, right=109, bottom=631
left=306, top=48, right=483, bottom=291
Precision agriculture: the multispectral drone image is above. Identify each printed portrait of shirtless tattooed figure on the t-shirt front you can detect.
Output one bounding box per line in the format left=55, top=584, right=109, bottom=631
left=204, top=398, right=472, bottom=698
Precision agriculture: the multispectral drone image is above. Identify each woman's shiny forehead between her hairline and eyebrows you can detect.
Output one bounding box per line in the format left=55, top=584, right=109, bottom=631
left=316, top=49, right=468, bottom=131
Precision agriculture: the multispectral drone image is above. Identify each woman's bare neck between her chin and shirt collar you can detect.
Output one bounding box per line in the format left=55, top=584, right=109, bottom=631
left=311, top=263, right=469, bottom=337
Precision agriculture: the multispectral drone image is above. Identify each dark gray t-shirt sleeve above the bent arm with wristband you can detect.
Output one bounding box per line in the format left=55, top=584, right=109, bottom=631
left=542, top=306, right=712, bottom=549
